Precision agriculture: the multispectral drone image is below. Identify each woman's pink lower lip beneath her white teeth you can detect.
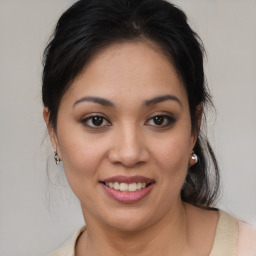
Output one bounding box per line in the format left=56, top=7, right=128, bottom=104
left=101, top=184, right=154, bottom=204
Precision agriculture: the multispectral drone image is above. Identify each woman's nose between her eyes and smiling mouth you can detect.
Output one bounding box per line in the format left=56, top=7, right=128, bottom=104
left=109, top=126, right=149, bottom=168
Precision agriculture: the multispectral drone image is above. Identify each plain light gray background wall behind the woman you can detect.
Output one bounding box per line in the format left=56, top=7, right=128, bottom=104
left=0, top=0, right=256, bottom=256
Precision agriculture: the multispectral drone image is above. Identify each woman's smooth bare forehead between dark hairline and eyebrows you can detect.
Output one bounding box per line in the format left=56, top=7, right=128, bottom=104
left=60, top=40, right=187, bottom=107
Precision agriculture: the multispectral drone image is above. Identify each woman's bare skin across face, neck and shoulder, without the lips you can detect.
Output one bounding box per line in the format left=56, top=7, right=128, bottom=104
left=44, top=40, right=218, bottom=256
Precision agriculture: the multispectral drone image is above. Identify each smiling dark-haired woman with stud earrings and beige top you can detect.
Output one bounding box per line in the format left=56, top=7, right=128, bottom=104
left=42, top=0, right=256, bottom=256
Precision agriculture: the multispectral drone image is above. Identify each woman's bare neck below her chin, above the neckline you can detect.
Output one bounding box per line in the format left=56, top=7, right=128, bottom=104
left=76, top=201, right=188, bottom=256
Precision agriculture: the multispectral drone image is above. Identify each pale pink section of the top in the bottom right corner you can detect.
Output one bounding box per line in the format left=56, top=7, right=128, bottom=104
left=237, top=221, right=256, bottom=256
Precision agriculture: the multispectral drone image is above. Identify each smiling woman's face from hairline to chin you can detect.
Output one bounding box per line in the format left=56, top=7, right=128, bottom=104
left=45, top=40, right=195, bottom=230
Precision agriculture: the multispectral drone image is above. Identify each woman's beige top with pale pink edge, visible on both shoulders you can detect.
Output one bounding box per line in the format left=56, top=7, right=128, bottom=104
left=50, top=210, right=256, bottom=256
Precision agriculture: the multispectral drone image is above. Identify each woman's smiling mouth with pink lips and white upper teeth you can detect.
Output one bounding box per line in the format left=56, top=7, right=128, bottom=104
left=100, top=176, right=155, bottom=203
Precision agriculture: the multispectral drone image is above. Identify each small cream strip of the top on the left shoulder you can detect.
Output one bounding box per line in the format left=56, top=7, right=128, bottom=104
left=49, top=226, right=86, bottom=256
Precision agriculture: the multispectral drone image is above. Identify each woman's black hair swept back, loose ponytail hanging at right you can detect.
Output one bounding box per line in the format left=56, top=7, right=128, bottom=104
left=42, top=0, right=219, bottom=208
